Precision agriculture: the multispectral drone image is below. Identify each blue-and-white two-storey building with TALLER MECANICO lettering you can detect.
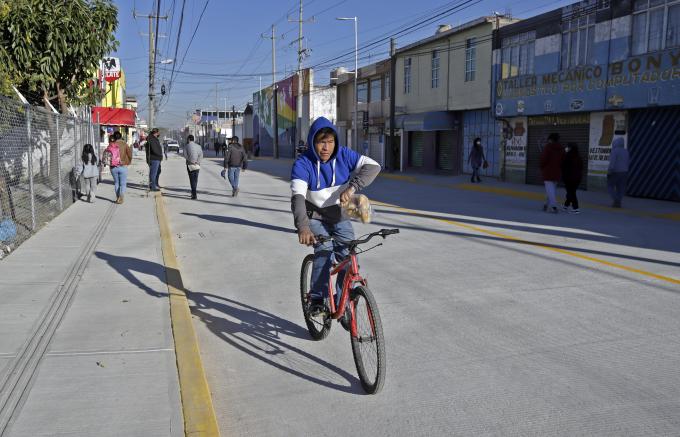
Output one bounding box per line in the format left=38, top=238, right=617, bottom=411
left=492, top=0, right=680, bottom=201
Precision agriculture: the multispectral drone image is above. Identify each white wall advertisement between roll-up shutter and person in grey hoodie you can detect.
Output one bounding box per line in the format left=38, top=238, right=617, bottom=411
left=588, top=112, right=628, bottom=176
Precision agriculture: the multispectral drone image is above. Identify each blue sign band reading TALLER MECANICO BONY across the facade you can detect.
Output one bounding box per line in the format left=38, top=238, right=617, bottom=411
left=496, top=49, right=680, bottom=99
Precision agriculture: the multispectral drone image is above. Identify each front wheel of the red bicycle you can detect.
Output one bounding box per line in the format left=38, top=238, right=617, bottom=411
left=350, top=286, right=387, bottom=394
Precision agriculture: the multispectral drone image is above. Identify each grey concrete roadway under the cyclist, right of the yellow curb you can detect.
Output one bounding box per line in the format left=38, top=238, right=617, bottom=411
left=161, top=152, right=680, bottom=436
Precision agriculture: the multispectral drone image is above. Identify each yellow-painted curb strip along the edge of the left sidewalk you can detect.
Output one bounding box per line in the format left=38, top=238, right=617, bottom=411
left=155, top=193, right=220, bottom=437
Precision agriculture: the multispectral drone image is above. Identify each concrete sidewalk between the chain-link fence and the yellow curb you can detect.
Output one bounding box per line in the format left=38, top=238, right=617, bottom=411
left=0, top=157, right=184, bottom=436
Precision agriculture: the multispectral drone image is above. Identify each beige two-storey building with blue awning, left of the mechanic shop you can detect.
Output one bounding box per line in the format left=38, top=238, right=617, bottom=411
left=395, top=15, right=516, bottom=176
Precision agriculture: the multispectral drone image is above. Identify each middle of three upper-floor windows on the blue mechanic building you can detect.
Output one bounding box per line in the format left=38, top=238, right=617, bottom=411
left=561, top=12, right=596, bottom=69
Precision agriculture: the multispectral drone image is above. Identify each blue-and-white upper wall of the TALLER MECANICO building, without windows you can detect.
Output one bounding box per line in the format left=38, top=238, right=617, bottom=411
left=493, top=4, right=680, bottom=117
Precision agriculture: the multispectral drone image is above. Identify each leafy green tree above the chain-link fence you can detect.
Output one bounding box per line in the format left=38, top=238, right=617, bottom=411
left=0, top=0, right=118, bottom=113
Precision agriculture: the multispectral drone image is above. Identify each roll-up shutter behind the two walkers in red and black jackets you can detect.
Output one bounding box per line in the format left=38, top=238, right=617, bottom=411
left=526, top=114, right=590, bottom=186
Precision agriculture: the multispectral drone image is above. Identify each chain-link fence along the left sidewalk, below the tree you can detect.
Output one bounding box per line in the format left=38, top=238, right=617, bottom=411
left=0, top=96, right=101, bottom=258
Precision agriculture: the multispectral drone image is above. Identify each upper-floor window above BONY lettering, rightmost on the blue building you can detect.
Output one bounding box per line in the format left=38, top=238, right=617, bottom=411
left=631, top=0, right=680, bottom=55
